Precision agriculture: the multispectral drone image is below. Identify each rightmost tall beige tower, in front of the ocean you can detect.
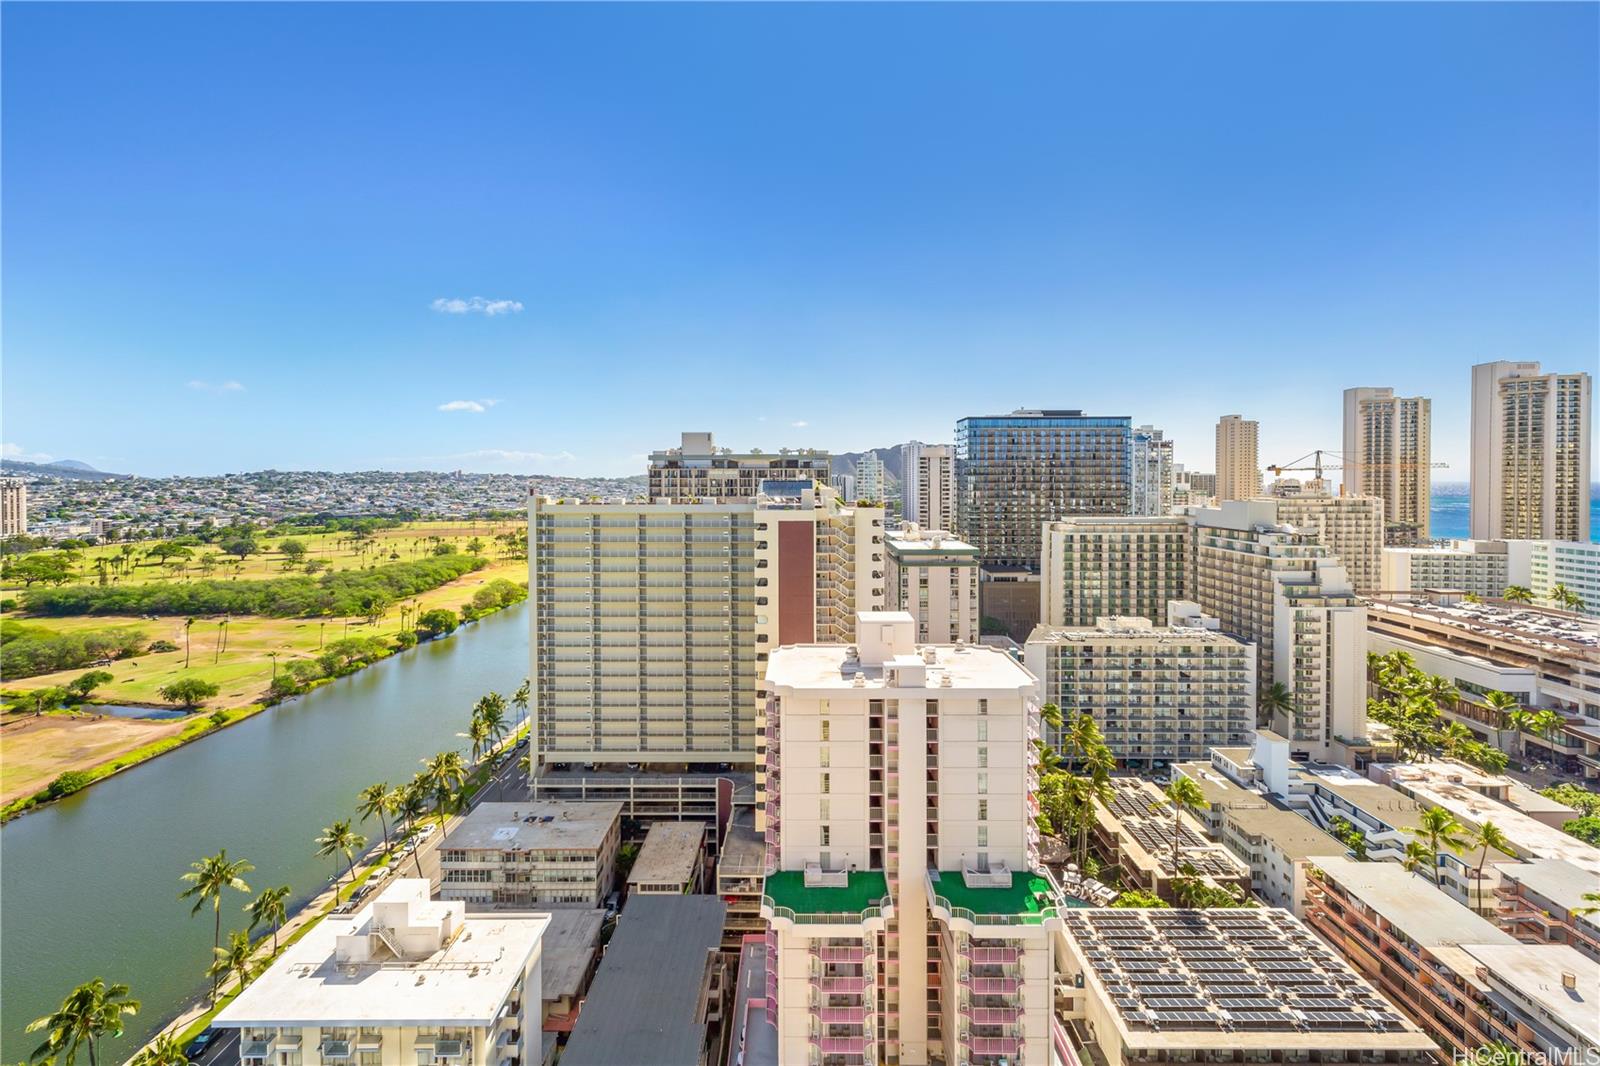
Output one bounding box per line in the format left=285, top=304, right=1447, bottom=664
left=1472, top=360, right=1594, bottom=541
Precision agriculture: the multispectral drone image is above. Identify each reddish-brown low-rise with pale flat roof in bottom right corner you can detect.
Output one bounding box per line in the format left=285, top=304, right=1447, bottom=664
left=1307, top=858, right=1600, bottom=1061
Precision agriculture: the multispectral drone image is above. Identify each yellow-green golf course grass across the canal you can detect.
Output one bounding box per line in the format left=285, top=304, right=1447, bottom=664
left=0, top=522, right=528, bottom=804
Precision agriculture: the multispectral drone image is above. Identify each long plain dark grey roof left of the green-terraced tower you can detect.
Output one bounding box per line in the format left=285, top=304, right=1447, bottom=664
left=562, top=895, right=726, bottom=1066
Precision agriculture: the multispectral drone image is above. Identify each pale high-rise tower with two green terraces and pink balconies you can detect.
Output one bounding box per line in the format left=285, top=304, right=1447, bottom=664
left=762, top=611, right=1064, bottom=1066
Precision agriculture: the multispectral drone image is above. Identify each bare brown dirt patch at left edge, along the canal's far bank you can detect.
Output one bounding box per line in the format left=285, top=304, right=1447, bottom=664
left=0, top=714, right=184, bottom=805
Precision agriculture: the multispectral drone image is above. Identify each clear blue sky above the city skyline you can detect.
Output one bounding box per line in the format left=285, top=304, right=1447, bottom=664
left=0, top=3, right=1600, bottom=480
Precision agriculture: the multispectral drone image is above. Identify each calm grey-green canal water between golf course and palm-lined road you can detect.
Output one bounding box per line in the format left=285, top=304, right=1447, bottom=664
left=0, top=603, right=528, bottom=1063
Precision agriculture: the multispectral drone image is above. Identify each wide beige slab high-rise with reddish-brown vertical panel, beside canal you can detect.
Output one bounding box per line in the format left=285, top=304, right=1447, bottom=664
left=528, top=479, right=885, bottom=771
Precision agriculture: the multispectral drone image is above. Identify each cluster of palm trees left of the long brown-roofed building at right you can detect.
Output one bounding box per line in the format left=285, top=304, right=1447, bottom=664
left=1366, top=651, right=1523, bottom=773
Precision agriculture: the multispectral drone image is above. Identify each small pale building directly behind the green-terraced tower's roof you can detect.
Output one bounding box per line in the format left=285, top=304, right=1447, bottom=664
left=885, top=525, right=979, bottom=643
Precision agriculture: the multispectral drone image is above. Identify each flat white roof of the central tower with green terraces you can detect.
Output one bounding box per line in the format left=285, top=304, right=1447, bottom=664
left=766, top=640, right=1035, bottom=691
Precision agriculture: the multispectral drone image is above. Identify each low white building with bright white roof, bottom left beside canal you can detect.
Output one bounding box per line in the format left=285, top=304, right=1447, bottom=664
left=213, top=879, right=549, bottom=1066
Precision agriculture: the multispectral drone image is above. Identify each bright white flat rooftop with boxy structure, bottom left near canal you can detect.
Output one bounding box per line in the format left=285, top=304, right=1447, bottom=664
left=216, top=877, right=550, bottom=1028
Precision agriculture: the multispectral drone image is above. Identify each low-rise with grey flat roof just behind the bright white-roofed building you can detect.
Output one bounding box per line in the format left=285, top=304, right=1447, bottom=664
left=438, top=800, right=622, bottom=908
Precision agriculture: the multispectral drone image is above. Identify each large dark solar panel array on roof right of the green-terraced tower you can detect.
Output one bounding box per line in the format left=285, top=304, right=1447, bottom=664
left=1062, top=908, right=1403, bottom=1032
